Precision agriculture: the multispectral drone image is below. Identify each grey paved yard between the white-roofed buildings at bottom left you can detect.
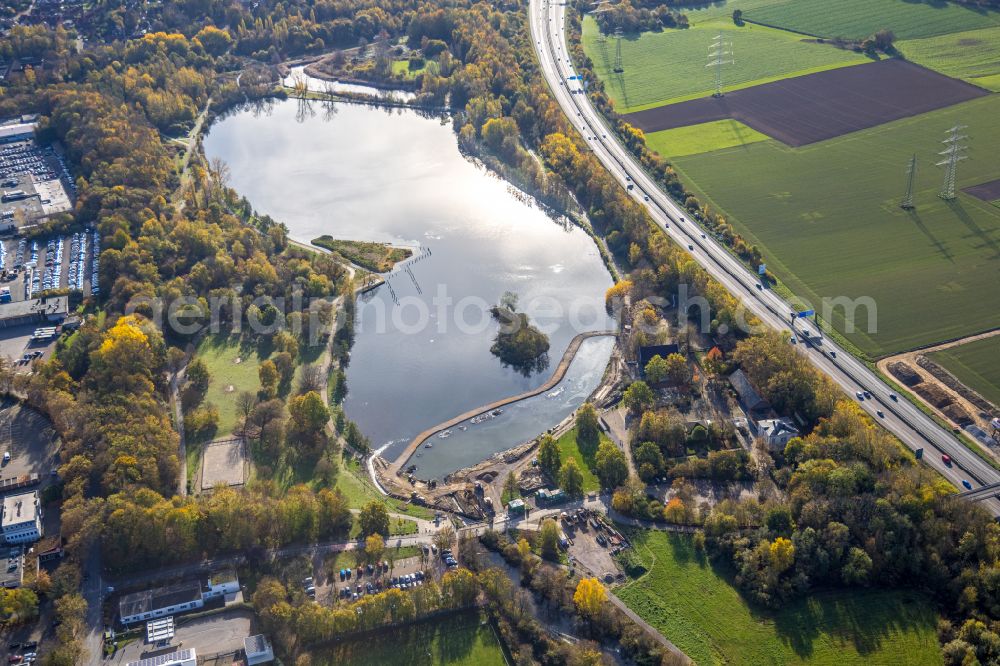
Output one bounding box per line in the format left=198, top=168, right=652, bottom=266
left=102, top=610, right=253, bottom=664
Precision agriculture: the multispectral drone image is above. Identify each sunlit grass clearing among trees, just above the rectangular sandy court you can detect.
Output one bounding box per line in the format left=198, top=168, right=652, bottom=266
left=196, top=335, right=262, bottom=437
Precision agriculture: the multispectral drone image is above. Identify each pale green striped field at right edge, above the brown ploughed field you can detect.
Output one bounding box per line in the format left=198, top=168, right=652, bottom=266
left=896, top=27, right=1000, bottom=92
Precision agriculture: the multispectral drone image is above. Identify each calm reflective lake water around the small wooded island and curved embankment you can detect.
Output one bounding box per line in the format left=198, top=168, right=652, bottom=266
left=205, top=94, right=613, bottom=478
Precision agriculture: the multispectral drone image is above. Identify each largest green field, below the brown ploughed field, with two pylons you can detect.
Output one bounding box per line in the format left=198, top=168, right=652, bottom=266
left=674, top=95, right=1000, bottom=357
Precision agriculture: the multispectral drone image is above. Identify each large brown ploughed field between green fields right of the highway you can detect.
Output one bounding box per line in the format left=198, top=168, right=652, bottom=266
left=624, top=59, right=989, bottom=146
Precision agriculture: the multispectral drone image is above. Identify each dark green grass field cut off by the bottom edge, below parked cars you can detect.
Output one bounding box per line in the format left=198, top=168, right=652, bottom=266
left=310, top=613, right=505, bottom=666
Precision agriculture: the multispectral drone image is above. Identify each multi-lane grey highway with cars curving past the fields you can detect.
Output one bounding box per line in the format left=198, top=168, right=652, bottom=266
left=529, top=0, right=1000, bottom=517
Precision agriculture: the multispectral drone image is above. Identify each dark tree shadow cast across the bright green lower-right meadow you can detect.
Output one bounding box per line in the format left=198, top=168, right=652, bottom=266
left=758, top=589, right=933, bottom=658
